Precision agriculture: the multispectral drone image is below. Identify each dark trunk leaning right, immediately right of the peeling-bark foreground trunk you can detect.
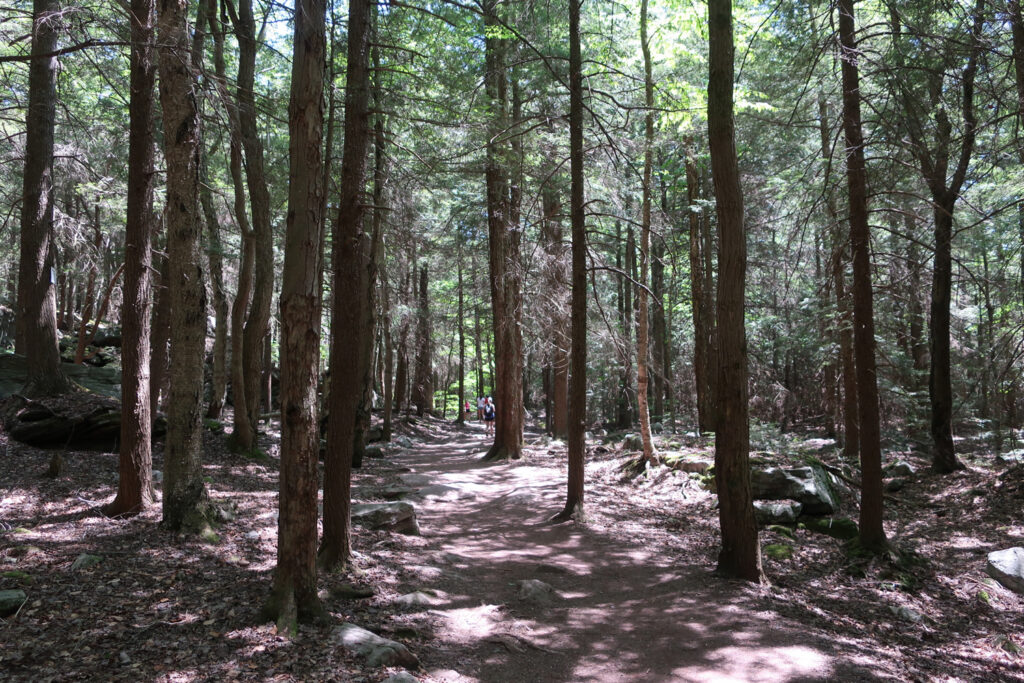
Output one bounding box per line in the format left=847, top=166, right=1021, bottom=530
left=319, top=0, right=376, bottom=569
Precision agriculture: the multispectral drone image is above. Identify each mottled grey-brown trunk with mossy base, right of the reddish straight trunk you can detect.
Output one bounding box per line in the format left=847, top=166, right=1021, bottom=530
left=158, top=0, right=208, bottom=530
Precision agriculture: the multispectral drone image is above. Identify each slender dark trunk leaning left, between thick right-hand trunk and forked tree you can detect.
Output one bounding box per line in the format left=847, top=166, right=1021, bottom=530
left=839, top=0, right=886, bottom=552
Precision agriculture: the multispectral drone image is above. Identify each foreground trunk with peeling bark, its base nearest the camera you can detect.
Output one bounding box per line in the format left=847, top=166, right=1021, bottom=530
left=266, top=0, right=326, bottom=633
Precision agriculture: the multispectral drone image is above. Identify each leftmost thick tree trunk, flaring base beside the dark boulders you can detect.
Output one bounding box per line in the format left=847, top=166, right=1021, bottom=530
left=15, top=0, right=73, bottom=397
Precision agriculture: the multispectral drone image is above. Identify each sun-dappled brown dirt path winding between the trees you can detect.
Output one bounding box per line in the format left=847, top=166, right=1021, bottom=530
left=368, top=426, right=889, bottom=681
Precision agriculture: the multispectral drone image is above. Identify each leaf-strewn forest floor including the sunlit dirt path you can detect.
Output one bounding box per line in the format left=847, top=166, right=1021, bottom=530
left=0, top=413, right=1024, bottom=683
